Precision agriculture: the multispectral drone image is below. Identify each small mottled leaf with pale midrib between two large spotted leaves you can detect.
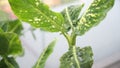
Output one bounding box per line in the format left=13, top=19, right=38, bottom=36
left=61, top=4, right=84, bottom=30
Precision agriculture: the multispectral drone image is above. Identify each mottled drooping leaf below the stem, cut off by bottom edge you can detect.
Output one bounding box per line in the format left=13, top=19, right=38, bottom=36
left=60, top=46, right=93, bottom=68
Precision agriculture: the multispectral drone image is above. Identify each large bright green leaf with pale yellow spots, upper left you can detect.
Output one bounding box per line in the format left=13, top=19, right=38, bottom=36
left=9, top=0, right=64, bottom=32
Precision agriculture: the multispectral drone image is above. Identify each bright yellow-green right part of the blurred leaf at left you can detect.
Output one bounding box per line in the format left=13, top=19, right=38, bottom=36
left=5, top=33, right=23, bottom=56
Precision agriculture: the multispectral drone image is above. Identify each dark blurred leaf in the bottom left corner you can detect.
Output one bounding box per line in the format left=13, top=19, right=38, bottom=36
left=0, top=57, right=19, bottom=68
